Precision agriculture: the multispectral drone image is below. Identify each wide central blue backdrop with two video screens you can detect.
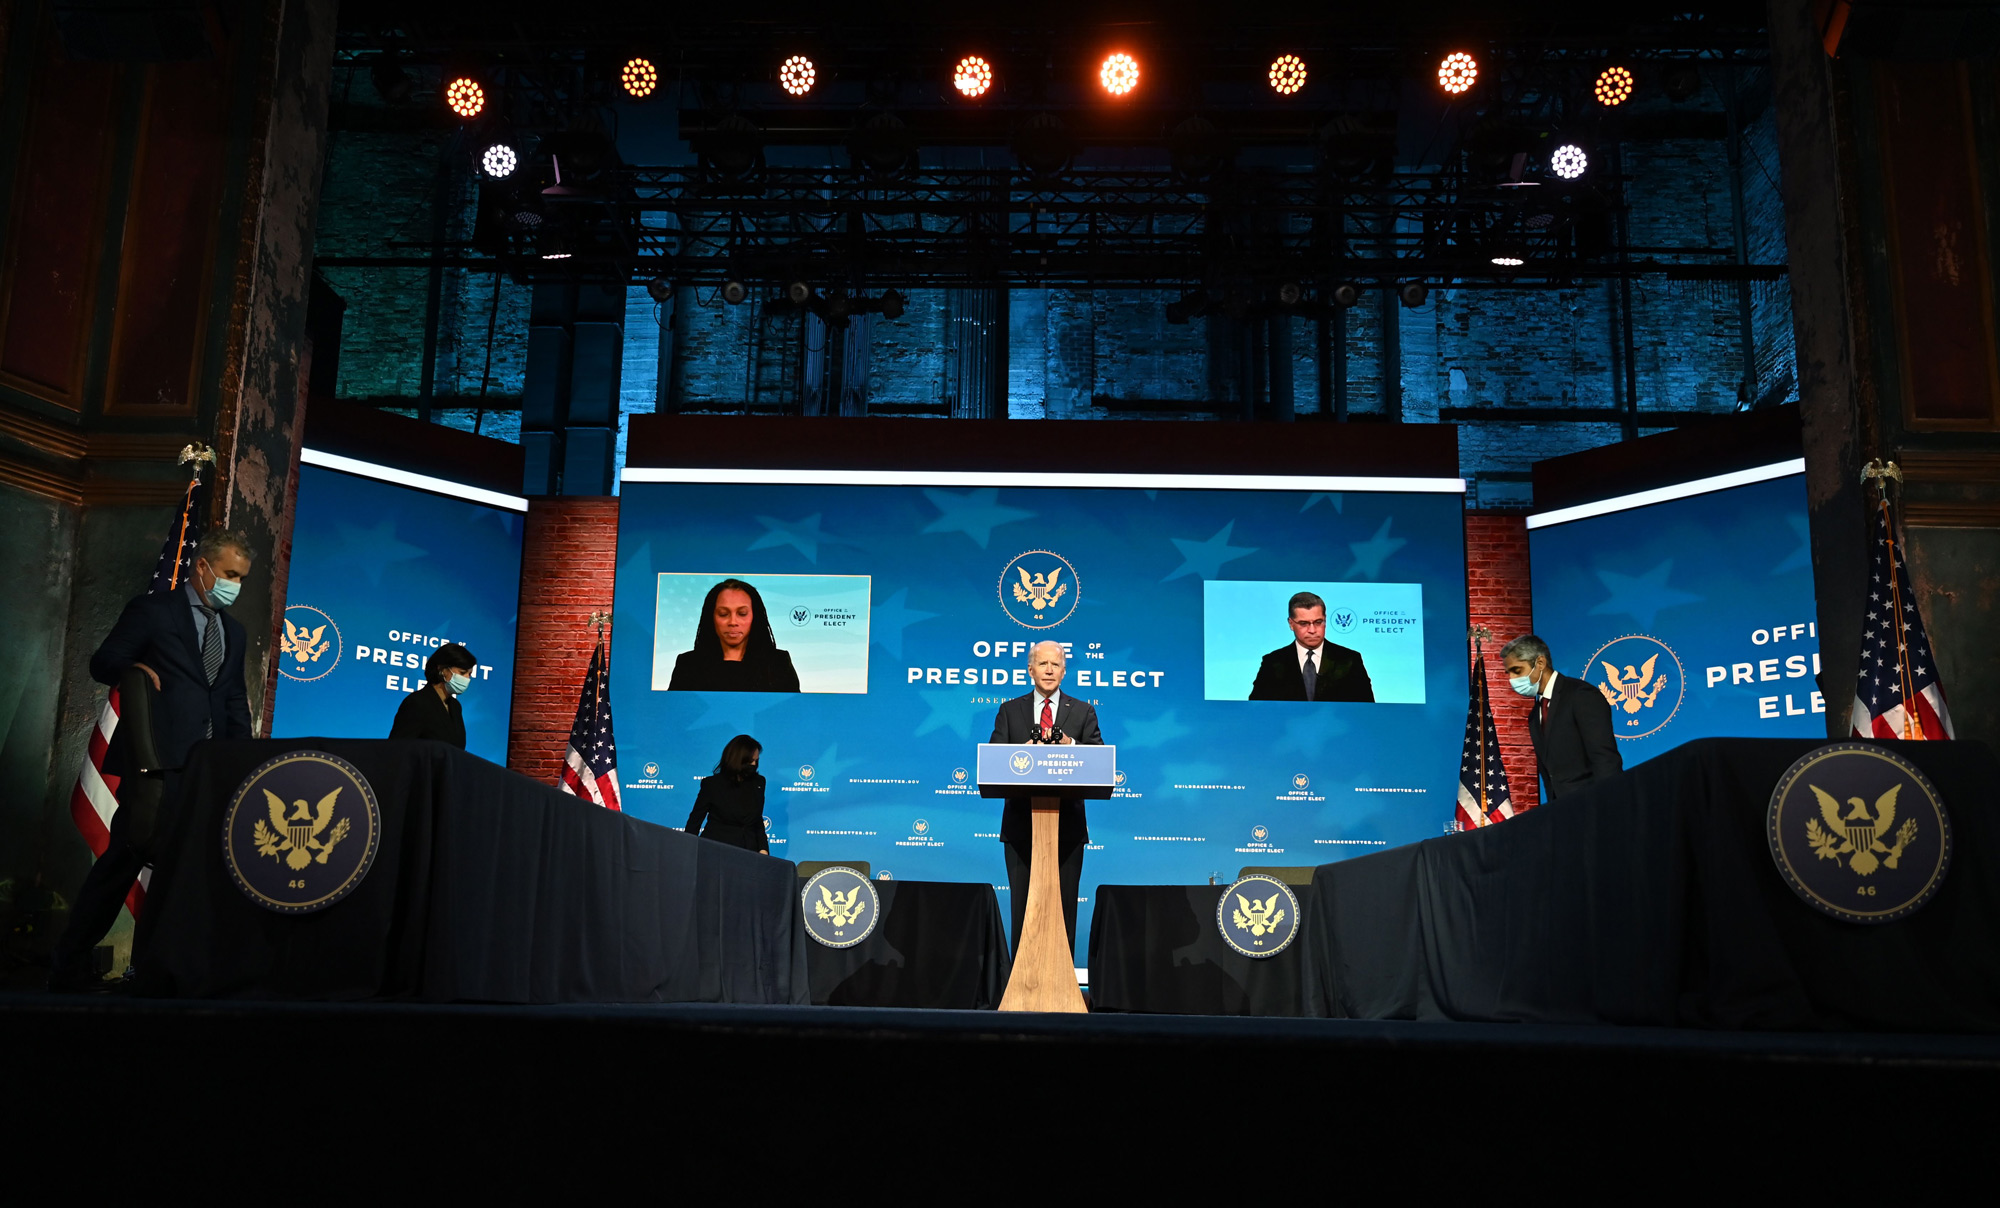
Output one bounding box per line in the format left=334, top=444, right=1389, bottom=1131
left=612, top=480, right=1466, bottom=946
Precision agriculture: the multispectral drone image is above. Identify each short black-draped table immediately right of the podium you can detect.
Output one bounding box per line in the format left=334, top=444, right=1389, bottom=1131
left=1090, top=886, right=1312, bottom=1016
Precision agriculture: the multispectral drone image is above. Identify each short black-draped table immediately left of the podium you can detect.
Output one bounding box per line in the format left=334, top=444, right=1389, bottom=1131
left=794, top=880, right=1012, bottom=1010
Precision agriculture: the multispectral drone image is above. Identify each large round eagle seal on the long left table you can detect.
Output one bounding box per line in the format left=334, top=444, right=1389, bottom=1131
left=222, top=750, right=382, bottom=914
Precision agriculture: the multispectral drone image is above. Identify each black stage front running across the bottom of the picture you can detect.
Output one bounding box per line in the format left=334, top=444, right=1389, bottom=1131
left=0, top=994, right=2000, bottom=1202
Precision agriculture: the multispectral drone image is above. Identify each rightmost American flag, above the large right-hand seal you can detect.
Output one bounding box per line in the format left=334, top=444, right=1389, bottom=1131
left=1852, top=500, right=1956, bottom=738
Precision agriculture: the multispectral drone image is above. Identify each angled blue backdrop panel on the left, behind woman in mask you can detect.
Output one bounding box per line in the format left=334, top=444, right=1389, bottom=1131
left=270, top=466, right=522, bottom=764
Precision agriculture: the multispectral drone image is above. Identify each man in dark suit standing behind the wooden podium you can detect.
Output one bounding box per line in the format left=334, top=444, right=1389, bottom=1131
left=988, top=642, right=1104, bottom=954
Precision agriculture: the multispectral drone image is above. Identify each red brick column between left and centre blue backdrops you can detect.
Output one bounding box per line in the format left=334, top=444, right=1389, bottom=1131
left=506, top=496, right=618, bottom=784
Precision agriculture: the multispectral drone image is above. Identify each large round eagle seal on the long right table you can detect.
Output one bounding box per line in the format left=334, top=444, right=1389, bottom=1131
left=1764, top=742, right=1952, bottom=922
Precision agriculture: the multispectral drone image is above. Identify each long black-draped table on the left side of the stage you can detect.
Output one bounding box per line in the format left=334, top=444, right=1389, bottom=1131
left=136, top=738, right=810, bottom=1004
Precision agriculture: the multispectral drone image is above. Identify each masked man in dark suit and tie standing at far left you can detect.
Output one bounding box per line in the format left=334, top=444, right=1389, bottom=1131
left=48, top=532, right=250, bottom=990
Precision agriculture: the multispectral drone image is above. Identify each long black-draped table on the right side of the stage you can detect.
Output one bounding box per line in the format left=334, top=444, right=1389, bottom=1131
left=1304, top=738, right=2000, bottom=1032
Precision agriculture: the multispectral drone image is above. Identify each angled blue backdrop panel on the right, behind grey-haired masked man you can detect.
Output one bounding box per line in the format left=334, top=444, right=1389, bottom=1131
left=1520, top=474, right=1826, bottom=768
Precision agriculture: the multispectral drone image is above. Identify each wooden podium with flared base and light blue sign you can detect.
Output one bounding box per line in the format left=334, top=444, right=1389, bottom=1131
left=978, top=742, right=1118, bottom=1012
